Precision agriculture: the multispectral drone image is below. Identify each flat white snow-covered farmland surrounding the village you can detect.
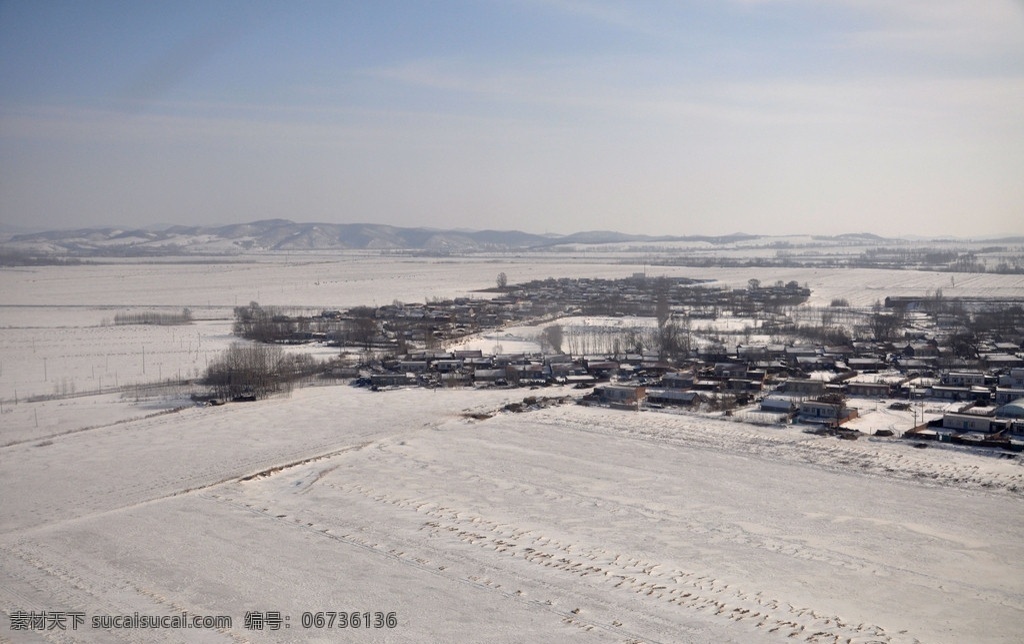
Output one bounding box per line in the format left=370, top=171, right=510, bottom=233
left=0, top=256, right=1024, bottom=642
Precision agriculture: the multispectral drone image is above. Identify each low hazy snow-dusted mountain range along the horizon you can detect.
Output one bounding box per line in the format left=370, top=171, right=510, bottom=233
left=0, top=219, right=1021, bottom=258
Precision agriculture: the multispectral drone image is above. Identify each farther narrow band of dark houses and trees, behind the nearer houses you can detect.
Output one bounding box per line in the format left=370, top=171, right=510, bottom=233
left=245, top=273, right=810, bottom=353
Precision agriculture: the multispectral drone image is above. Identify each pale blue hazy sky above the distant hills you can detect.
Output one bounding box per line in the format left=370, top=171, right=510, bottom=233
left=0, top=0, right=1024, bottom=238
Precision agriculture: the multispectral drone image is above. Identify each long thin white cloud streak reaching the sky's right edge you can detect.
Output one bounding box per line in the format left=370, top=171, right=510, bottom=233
left=358, top=51, right=1024, bottom=133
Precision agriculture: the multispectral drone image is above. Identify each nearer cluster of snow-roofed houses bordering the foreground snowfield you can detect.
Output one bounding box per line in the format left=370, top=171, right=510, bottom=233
left=357, top=339, right=1024, bottom=438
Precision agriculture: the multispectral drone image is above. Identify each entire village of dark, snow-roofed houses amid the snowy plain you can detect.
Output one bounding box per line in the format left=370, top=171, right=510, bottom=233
left=226, top=273, right=1024, bottom=450
